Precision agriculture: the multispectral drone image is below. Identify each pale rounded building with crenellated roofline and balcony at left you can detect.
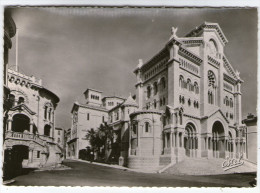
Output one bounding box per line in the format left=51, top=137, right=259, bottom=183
left=4, top=69, right=62, bottom=170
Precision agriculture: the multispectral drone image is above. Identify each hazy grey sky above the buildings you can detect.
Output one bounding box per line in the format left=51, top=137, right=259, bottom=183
left=6, top=8, right=257, bottom=129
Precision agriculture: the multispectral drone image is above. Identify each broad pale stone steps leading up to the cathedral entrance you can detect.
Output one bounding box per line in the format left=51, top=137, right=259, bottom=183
left=164, top=158, right=257, bottom=175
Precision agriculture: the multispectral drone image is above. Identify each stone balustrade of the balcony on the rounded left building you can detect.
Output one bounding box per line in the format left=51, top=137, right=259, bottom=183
left=5, top=131, right=54, bottom=146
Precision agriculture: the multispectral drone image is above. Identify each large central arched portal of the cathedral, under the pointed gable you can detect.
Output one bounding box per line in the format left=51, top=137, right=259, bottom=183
left=212, top=121, right=225, bottom=158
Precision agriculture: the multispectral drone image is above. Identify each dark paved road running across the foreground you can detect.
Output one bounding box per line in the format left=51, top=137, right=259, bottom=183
left=8, top=160, right=256, bottom=187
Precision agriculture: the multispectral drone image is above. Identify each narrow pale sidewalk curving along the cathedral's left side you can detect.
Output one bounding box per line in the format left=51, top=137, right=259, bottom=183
left=68, top=159, right=157, bottom=173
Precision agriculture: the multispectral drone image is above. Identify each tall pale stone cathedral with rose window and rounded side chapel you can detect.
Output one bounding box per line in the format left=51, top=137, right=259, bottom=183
left=128, top=22, right=246, bottom=168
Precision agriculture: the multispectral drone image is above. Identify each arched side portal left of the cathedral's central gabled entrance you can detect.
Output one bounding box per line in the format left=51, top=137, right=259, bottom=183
left=184, top=123, right=198, bottom=157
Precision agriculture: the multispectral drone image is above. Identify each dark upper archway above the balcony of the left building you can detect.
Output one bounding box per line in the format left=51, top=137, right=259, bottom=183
left=12, top=114, right=30, bottom=132
